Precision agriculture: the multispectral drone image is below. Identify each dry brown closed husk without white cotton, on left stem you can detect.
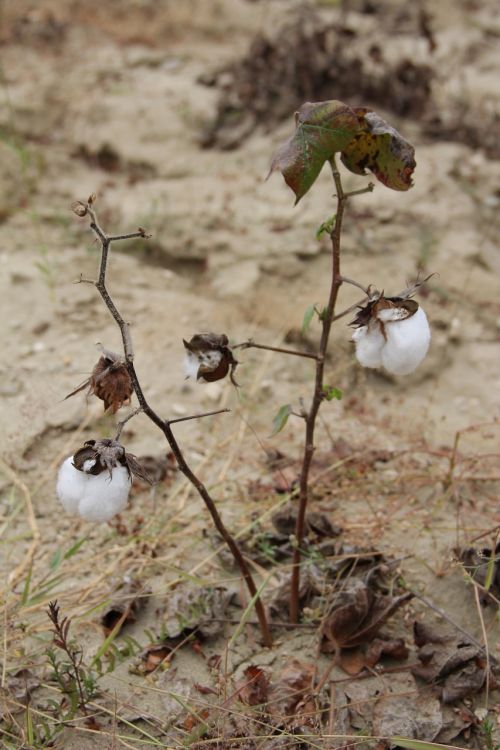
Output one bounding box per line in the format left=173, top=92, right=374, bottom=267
left=66, top=349, right=134, bottom=414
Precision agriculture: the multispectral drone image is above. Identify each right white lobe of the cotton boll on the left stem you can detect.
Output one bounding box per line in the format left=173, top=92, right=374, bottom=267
left=78, top=466, right=132, bottom=521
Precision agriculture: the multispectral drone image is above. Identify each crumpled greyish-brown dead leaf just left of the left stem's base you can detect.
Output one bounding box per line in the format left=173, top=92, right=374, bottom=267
left=163, top=583, right=234, bottom=638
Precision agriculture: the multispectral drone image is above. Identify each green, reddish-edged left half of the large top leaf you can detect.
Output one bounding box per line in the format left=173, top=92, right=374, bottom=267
left=269, top=100, right=359, bottom=204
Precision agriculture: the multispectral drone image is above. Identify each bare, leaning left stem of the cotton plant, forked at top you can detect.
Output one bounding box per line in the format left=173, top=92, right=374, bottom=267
left=81, top=203, right=272, bottom=646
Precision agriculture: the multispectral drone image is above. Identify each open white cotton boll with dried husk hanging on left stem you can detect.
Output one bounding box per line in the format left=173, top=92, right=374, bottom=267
left=56, top=439, right=149, bottom=521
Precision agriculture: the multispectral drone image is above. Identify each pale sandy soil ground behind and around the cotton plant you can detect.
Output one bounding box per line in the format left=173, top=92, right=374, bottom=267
left=0, top=0, right=500, bottom=748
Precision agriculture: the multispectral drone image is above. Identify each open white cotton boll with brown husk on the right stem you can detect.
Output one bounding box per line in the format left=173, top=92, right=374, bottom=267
left=351, top=289, right=431, bottom=375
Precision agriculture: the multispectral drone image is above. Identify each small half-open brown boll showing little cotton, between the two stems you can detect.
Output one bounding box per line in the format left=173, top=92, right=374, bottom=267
left=183, top=333, right=238, bottom=386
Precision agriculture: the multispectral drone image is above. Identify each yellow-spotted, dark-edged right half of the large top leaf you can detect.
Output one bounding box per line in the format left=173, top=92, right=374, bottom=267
left=341, top=107, right=416, bottom=190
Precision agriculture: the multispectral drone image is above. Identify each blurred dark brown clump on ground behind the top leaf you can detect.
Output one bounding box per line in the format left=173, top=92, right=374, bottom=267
left=201, top=7, right=435, bottom=149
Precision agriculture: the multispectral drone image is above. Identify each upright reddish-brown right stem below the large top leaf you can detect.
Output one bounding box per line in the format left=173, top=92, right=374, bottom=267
left=289, top=159, right=348, bottom=623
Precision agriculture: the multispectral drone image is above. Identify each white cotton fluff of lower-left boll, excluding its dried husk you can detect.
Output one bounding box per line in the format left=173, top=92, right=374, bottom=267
left=56, top=456, right=132, bottom=522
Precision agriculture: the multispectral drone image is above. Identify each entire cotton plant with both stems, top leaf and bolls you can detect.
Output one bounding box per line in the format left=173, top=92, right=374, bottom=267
left=58, top=101, right=430, bottom=646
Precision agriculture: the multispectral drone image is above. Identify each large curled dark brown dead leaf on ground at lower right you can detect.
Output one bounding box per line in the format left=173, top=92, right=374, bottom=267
left=412, top=622, right=486, bottom=703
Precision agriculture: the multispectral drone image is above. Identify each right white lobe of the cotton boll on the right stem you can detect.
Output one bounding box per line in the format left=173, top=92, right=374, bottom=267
left=382, top=307, right=431, bottom=375
